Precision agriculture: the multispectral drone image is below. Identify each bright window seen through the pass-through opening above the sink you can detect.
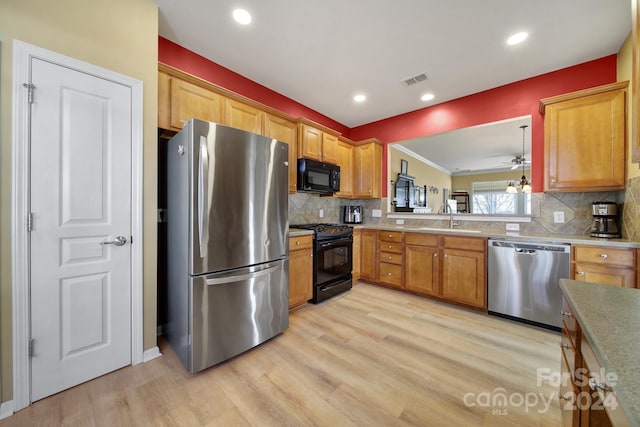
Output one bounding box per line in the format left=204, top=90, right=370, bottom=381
left=471, top=181, right=531, bottom=215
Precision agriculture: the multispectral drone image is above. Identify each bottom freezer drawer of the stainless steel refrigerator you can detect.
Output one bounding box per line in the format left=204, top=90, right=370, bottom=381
left=188, top=260, right=289, bottom=372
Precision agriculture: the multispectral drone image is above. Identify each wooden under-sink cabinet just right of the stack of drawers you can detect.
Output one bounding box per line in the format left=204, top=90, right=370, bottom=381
left=404, top=233, right=440, bottom=297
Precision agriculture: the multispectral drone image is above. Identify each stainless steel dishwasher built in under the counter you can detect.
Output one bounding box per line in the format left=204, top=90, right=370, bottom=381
left=487, top=239, right=571, bottom=330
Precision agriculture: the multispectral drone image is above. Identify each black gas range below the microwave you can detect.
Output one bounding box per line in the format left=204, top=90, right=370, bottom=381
left=291, top=224, right=353, bottom=304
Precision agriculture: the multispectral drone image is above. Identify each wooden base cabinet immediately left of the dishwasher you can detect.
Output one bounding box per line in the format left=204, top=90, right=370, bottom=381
left=441, top=235, right=487, bottom=309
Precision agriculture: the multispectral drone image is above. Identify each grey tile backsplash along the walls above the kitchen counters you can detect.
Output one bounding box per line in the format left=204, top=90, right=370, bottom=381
left=289, top=189, right=640, bottom=241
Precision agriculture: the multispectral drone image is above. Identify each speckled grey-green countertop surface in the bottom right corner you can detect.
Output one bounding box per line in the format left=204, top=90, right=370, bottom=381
left=560, top=279, right=640, bottom=425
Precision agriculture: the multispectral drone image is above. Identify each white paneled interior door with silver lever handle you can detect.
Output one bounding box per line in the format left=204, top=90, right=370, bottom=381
left=30, top=58, right=132, bottom=401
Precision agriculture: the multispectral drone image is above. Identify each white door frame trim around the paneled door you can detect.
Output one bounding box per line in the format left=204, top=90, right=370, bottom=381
left=11, top=40, right=143, bottom=410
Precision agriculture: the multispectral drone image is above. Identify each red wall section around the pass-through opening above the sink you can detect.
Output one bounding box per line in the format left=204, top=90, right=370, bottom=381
left=349, top=55, right=616, bottom=195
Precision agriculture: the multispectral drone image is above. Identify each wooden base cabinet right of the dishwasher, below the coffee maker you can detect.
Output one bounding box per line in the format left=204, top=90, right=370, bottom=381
left=571, top=245, right=637, bottom=288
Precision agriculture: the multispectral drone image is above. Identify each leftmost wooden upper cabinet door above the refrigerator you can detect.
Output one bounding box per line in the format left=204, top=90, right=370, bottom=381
left=169, top=78, right=222, bottom=129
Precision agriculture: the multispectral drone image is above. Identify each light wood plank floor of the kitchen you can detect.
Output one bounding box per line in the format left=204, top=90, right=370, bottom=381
left=0, top=283, right=561, bottom=427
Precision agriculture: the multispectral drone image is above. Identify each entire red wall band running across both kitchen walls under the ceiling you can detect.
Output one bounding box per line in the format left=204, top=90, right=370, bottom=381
left=158, top=37, right=616, bottom=196
